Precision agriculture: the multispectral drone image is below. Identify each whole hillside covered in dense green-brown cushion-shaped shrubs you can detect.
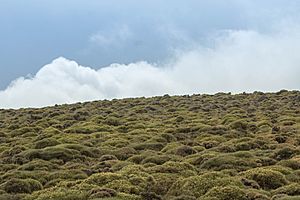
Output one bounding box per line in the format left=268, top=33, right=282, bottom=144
left=0, top=90, right=300, bottom=200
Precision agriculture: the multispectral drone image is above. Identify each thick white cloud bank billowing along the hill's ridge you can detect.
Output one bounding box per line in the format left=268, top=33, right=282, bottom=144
left=0, top=27, right=300, bottom=108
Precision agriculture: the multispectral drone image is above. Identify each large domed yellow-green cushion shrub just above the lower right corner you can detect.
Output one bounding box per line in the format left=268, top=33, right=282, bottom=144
left=244, top=168, right=287, bottom=190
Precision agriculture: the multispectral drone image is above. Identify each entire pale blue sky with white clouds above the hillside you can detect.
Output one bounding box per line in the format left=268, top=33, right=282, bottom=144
left=0, top=0, right=300, bottom=108
